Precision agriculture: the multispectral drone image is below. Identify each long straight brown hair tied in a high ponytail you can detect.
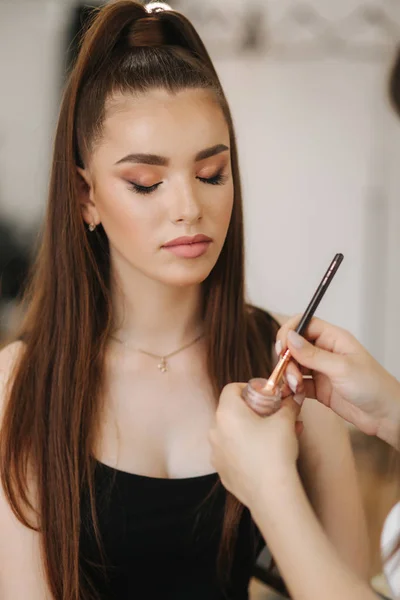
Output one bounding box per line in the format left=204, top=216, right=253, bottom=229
left=0, top=0, right=272, bottom=600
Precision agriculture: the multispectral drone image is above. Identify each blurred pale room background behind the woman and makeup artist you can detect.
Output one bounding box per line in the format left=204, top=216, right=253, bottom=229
left=0, top=0, right=400, bottom=598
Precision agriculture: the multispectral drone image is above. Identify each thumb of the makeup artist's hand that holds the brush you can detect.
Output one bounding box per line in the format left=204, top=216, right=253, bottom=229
left=287, top=330, right=343, bottom=377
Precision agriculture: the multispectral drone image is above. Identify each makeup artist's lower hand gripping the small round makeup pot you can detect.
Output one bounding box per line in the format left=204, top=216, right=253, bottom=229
left=210, top=383, right=302, bottom=508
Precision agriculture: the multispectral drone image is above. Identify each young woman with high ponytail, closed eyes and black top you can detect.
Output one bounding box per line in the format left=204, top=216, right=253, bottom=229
left=0, top=1, right=367, bottom=600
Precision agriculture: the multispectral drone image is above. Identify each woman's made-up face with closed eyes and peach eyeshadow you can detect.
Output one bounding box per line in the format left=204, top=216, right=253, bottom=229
left=81, top=89, right=234, bottom=286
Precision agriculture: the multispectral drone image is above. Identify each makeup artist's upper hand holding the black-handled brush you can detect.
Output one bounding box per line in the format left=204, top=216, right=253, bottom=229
left=277, top=317, right=400, bottom=447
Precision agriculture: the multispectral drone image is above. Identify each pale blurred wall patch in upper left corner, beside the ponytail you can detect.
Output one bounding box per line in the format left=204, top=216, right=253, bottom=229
left=0, top=0, right=69, bottom=230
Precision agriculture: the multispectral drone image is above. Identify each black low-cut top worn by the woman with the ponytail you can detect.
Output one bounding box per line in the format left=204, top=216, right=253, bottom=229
left=80, top=309, right=278, bottom=600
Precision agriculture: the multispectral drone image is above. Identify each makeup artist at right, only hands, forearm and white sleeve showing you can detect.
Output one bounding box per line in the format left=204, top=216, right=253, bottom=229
left=210, top=319, right=400, bottom=600
